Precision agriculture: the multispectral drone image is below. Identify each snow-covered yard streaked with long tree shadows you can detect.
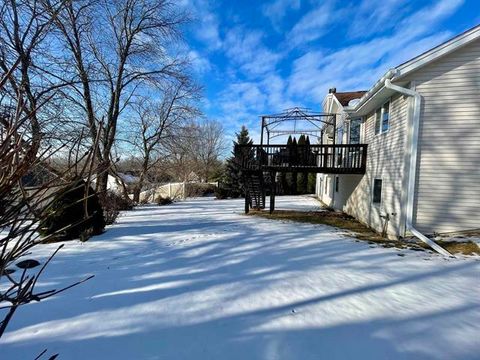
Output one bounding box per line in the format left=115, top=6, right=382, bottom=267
left=0, top=197, right=480, bottom=360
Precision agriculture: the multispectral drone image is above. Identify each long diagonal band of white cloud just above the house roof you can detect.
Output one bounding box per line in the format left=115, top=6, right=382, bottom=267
left=288, top=0, right=462, bottom=104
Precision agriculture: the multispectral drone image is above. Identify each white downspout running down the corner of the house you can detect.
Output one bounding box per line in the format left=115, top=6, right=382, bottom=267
left=385, top=79, right=452, bottom=256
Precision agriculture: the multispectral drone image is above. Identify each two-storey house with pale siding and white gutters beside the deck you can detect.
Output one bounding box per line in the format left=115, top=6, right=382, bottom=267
left=317, top=26, right=480, bottom=237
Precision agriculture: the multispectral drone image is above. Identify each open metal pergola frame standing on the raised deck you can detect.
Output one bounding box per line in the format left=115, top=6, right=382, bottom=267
left=260, top=107, right=337, bottom=146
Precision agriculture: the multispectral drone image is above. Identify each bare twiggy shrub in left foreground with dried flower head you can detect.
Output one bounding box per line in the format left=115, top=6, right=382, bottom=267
left=0, top=105, right=97, bottom=337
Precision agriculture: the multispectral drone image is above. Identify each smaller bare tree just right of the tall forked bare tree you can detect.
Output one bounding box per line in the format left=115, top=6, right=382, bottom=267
left=125, top=79, right=200, bottom=202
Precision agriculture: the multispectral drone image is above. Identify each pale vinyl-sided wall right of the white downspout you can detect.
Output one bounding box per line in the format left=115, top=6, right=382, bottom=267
left=402, top=40, right=480, bottom=233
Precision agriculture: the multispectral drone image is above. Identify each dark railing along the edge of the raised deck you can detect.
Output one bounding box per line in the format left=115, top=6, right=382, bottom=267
left=235, top=144, right=367, bottom=174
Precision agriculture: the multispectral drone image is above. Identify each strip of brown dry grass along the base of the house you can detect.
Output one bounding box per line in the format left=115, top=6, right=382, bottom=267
left=249, top=210, right=480, bottom=255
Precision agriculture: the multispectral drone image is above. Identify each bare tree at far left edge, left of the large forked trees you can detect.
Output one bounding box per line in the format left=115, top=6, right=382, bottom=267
left=0, top=0, right=70, bottom=170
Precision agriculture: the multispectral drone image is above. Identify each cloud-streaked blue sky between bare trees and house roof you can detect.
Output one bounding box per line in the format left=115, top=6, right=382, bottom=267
left=181, top=0, right=480, bottom=143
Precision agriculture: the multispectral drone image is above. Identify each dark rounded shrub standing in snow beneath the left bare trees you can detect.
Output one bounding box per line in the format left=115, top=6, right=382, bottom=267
left=39, top=179, right=105, bottom=241
